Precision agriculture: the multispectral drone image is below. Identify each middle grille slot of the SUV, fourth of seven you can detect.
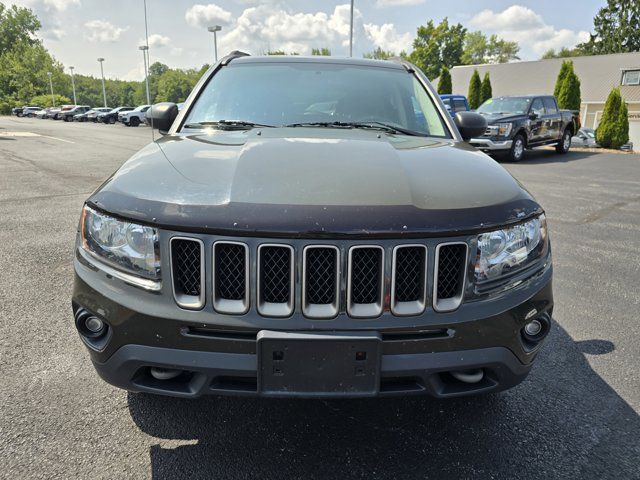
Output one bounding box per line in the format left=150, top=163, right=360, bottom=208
left=302, top=245, right=340, bottom=318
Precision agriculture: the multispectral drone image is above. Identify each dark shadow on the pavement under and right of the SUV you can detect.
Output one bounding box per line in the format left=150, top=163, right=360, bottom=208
left=128, top=324, right=640, bottom=479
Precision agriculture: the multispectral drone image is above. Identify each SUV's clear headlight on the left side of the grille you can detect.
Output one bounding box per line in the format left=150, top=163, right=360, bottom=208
left=81, top=207, right=160, bottom=280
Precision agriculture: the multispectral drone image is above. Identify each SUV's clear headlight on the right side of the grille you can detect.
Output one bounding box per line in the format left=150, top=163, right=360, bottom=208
left=475, top=215, right=549, bottom=285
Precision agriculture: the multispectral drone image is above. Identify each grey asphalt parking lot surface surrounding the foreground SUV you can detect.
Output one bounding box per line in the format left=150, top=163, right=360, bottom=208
left=0, top=117, right=640, bottom=479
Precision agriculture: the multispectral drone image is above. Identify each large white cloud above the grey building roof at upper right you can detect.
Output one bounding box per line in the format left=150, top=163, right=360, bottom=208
left=469, top=5, right=589, bottom=55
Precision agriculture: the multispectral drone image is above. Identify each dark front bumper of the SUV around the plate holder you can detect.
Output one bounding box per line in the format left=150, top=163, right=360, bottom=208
left=73, top=253, right=553, bottom=397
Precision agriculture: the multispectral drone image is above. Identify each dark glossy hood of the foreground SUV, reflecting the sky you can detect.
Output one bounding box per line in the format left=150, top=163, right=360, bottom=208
left=88, top=128, right=540, bottom=236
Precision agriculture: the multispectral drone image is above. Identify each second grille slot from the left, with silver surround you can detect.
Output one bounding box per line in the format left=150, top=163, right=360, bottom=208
left=213, top=241, right=249, bottom=314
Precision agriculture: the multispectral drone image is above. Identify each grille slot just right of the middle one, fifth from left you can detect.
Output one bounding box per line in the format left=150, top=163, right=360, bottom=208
left=347, top=245, right=384, bottom=318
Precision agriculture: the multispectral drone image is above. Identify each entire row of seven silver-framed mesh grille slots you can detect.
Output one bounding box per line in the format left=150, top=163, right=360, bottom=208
left=170, top=237, right=468, bottom=319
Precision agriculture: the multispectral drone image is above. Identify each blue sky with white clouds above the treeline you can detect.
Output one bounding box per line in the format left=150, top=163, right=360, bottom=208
left=7, top=0, right=606, bottom=80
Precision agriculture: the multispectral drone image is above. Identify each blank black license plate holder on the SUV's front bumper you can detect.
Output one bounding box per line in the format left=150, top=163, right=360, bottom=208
left=257, top=330, right=382, bottom=396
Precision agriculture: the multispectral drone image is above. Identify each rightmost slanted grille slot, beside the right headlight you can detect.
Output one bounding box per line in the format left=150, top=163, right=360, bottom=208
left=433, top=242, right=468, bottom=312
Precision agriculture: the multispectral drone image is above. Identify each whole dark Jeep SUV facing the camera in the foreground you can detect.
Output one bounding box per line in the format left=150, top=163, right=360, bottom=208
left=72, top=52, right=553, bottom=400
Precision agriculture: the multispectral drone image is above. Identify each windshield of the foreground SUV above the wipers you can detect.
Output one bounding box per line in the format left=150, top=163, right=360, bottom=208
left=185, top=61, right=449, bottom=138
